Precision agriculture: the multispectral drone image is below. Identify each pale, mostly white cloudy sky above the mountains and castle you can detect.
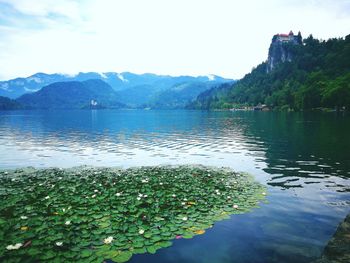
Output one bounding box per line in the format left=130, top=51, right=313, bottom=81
left=0, top=0, right=350, bottom=80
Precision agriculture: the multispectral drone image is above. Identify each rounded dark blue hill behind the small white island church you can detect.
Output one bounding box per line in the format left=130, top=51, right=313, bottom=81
left=17, top=79, right=124, bottom=109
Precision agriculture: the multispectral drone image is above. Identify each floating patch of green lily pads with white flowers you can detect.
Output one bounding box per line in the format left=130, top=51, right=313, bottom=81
left=0, top=166, right=266, bottom=262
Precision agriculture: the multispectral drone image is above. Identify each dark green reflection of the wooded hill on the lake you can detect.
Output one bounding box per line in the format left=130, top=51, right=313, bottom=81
left=238, top=112, right=350, bottom=188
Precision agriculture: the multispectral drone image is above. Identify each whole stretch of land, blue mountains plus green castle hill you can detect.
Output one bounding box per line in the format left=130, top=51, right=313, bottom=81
left=0, top=31, right=344, bottom=111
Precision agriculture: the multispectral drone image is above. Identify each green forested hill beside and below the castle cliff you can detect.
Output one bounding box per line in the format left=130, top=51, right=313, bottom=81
left=189, top=35, right=350, bottom=110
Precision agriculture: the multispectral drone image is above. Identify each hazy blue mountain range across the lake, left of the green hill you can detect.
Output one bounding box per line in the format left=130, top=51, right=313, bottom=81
left=0, top=72, right=233, bottom=109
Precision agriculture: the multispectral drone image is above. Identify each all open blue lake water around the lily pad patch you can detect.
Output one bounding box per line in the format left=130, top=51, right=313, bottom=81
left=0, top=110, right=350, bottom=263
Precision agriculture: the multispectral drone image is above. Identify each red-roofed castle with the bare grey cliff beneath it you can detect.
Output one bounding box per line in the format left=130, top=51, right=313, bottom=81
left=266, top=31, right=303, bottom=73
